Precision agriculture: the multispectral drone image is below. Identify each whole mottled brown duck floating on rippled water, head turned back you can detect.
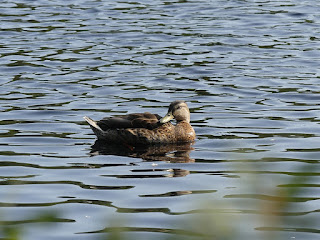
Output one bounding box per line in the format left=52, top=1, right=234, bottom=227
left=84, top=100, right=196, bottom=146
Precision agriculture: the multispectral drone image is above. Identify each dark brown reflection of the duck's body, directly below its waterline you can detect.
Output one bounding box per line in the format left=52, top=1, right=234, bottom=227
left=90, top=140, right=194, bottom=163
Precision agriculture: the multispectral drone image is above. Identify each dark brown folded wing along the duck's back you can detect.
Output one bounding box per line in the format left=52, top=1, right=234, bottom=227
left=97, top=112, right=161, bottom=130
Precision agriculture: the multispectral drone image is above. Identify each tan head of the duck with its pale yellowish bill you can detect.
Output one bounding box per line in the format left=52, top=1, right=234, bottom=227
left=159, top=101, right=190, bottom=123
